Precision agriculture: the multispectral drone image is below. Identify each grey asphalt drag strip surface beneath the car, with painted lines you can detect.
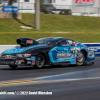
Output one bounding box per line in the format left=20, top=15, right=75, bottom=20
left=0, top=58, right=100, bottom=100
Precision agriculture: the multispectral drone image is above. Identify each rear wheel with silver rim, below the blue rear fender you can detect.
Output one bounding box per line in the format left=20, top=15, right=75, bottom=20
left=76, top=51, right=85, bottom=66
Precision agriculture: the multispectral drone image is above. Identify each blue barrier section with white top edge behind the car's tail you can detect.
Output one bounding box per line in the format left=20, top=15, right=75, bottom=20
left=84, top=43, right=100, bottom=57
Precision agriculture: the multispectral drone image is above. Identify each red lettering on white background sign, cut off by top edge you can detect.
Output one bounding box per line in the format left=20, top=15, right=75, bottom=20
left=75, top=0, right=95, bottom=6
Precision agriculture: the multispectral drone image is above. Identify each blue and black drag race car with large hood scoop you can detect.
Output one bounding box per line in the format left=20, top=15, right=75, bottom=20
left=0, top=37, right=95, bottom=69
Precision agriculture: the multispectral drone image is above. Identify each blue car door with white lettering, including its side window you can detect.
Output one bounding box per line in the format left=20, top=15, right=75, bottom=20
left=49, top=39, right=74, bottom=63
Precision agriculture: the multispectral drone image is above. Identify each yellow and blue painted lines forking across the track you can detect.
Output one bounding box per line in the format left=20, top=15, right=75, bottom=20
left=0, top=68, right=100, bottom=86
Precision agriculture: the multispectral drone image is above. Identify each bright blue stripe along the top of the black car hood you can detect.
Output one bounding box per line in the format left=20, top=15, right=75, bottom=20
left=4, top=45, right=44, bottom=54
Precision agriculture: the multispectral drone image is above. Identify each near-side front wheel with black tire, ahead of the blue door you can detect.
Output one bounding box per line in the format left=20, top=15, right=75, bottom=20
left=35, top=54, right=45, bottom=69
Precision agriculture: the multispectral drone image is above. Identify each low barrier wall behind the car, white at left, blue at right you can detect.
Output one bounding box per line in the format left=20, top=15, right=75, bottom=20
left=0, top=43, right=100, bottom=56
